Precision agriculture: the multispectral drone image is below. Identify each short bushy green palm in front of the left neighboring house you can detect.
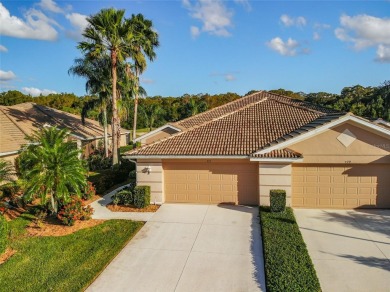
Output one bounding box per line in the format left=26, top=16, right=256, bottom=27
left=20, top=127, right=86, bottom=213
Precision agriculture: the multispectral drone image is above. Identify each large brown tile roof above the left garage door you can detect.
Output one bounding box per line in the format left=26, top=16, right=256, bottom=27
left=127, top=92, right=340, bottom=158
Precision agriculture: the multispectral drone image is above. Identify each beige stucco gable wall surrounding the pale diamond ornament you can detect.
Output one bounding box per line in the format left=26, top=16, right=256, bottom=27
left=288, top=122, right=390, bottom=164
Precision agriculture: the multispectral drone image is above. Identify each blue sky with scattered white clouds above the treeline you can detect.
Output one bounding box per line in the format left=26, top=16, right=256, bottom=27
left=0, top=0, right=390, bottom=96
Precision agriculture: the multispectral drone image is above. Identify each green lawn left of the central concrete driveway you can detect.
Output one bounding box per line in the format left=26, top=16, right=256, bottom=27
left=0, top=215, right=143, bottom=291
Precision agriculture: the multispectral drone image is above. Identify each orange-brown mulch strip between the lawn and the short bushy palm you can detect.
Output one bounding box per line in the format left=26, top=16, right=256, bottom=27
left=26, top=217, right=105, bottom=236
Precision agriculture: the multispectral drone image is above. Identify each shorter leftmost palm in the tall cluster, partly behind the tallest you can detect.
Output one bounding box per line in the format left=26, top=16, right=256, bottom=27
left=68, top=56, right=112, bottom=157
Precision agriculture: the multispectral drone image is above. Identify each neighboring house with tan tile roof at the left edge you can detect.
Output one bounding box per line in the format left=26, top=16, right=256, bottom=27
left=0, top=102, right=130, bottom=162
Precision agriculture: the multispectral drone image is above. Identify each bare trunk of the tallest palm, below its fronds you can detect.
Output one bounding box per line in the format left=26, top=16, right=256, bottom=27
left=111, top=50, right=119, bottom=165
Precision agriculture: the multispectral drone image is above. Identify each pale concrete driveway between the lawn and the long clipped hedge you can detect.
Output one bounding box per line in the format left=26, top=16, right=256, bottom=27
left=88, top=204, right=265, bottom=291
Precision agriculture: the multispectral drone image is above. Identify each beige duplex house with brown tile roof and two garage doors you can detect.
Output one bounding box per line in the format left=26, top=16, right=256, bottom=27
left=125, top=91, right=390, bottom=208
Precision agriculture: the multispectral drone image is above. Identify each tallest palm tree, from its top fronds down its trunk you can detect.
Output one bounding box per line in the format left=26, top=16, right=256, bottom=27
left=78, top=8, right=134, bottom=165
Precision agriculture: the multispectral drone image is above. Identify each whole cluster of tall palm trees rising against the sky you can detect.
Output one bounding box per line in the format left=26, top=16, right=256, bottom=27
left=69, top=8, right=159, bottom=164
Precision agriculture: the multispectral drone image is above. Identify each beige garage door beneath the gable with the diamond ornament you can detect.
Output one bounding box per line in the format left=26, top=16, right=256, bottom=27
left=292, top=164, right=390, bottom=209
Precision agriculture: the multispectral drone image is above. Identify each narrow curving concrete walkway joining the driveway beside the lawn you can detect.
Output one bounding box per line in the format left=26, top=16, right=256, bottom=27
left=90, top=184, right=155, bottom=221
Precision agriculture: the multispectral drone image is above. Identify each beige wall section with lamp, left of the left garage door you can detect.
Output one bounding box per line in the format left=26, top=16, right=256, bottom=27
left=137, top=159, right=165, bottom=204
